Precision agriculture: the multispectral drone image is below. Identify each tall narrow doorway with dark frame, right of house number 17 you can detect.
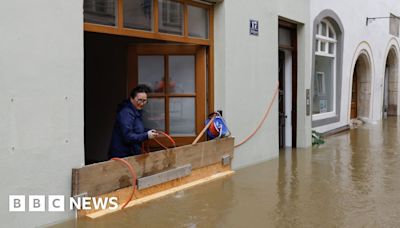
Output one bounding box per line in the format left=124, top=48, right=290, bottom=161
left=278, top=20, right=297, bottom=148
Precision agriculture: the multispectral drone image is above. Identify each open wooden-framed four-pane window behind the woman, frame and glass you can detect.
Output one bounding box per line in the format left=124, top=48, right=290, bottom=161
left=128, top=44, right=207, bottom=146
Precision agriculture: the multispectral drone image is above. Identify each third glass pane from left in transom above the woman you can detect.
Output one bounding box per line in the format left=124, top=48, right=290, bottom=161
left=158, top=0, right=183, bottom=35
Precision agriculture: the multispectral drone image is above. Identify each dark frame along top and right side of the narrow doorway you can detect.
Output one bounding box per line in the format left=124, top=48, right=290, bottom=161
left=278, top=18, right=298, bottom=148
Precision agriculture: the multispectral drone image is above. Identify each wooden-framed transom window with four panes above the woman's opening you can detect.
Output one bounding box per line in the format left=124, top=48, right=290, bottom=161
left=84, top=0, right=213, bottom=45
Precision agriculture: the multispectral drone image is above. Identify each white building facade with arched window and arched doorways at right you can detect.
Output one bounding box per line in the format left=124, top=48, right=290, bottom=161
left=309, top=1, right=400, bottom=132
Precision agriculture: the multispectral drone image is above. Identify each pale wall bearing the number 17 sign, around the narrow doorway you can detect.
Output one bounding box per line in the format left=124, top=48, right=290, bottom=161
left=215, top=0, right=311, bottom=169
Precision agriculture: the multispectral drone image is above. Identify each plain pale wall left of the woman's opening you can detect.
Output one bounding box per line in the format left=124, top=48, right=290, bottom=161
left=0, top=0, right=84, bottom=227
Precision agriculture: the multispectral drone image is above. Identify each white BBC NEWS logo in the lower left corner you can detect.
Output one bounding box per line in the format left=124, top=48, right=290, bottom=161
left=8, top=195, right=118, bottom=212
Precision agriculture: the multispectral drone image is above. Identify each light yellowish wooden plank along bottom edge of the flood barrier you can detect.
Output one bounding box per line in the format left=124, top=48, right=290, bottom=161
left=78, top=163, right=231, bottom=217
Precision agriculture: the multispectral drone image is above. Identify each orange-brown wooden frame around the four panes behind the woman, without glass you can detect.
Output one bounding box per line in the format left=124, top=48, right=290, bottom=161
left=127, top=44, right=207, bottom=146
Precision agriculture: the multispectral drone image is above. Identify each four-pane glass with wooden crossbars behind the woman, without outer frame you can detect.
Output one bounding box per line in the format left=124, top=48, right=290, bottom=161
left=138, top=55, right=196, bottom=136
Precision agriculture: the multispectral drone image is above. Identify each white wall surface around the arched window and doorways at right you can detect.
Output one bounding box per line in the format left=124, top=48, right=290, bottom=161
left=309, top=0, right=400, bottom=132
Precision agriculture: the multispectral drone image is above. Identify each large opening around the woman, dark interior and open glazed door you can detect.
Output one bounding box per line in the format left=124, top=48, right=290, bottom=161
left=84, top=32, right=208, bottom=165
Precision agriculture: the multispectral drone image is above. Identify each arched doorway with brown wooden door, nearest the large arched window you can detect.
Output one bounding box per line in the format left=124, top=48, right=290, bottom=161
left=350, top=53, right=371, bottom=120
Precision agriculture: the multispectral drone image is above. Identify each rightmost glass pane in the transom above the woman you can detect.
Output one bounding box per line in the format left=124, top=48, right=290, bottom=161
left=188, top=5, right=208, bottom=39
